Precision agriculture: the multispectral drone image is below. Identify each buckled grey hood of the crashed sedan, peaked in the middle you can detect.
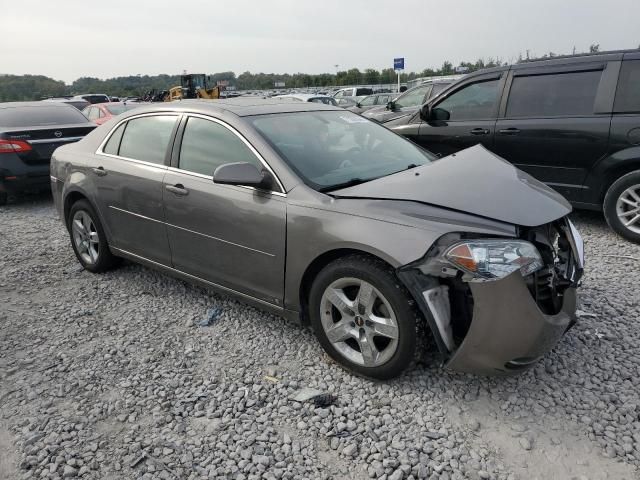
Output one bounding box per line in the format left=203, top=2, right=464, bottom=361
left=331, top=145, right=571, bottom=227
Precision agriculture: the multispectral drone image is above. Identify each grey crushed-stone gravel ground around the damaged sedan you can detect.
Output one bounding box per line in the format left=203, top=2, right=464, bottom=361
left=0, top=196, right=640, bottom=480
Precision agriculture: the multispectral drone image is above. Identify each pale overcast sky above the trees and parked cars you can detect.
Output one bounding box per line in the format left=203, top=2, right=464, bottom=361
left=0, top=0, right=640, bottom=83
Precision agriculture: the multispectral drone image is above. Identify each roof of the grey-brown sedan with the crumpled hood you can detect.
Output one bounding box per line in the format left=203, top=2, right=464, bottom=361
left=118, top=97, right=343, bottom=117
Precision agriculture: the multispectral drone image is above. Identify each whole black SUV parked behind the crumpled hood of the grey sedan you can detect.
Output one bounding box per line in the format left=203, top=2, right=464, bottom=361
left=385, top=50, right=640, bottom=242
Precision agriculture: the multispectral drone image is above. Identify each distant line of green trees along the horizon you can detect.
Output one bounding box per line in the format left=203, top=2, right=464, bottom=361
left=0, top=44, right=632, bottom=102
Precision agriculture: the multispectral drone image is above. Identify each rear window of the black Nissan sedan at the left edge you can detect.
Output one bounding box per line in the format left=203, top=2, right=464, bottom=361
left=0, top=104, right=88, bottom=127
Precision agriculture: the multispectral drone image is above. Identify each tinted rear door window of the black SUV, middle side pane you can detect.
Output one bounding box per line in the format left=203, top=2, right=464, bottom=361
left=506, top=70, right=602, bottom=117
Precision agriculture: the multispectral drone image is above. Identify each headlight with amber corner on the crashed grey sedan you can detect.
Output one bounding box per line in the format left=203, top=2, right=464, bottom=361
left=444, top=239, right=544, bottom=280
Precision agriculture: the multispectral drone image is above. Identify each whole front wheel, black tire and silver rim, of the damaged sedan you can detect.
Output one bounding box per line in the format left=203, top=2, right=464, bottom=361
left=309, top=255, right=419, bottom=380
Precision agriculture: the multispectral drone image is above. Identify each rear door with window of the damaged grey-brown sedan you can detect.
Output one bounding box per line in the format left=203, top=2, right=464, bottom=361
left=89, top=114, right=179, bottom=265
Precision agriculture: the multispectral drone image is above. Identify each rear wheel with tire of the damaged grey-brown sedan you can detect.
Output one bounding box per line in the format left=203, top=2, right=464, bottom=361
left=67, top=200, right=118, bottom=273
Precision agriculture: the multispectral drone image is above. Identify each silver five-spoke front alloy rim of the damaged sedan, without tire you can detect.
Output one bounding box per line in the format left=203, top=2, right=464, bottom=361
left=320, top=278, right=399, bottom=367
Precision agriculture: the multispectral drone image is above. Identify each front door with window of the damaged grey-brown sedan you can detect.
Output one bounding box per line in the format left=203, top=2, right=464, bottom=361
left=163, top=116, right=286, bottom=305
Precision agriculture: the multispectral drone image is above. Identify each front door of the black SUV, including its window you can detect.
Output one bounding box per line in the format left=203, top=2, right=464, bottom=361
left=416, top=72, right=506, bottom=155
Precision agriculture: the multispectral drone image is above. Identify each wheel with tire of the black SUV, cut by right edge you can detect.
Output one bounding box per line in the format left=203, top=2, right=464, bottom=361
left=603, top=170, right=640, bottom=243
